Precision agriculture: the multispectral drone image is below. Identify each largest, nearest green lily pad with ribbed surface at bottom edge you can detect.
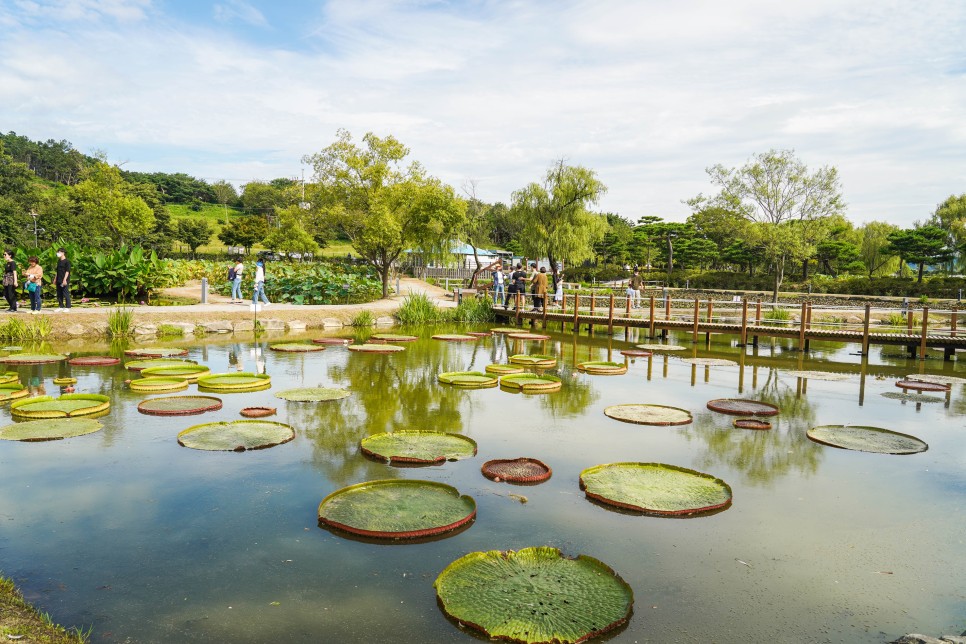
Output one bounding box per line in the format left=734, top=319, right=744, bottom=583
left=433, top=546, right=634, bottom=644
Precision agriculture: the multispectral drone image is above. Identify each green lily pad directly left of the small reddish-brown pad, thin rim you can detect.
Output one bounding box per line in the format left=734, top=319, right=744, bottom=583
left=359, top=430, right=476, bottom=463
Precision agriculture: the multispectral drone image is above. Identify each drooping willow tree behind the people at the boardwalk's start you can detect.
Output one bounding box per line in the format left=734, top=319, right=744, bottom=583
left=512, top=159, right=607, bottom=280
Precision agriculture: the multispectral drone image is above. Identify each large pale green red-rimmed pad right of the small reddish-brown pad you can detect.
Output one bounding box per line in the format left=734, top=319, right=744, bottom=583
left=580, top=463, right=731, bottom=516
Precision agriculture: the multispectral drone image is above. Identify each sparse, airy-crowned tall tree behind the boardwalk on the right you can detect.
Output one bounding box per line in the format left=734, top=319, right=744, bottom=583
left=692, top=150, right=845, bottom=302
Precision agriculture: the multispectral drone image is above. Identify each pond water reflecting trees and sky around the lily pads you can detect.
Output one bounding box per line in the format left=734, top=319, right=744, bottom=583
left=0, top=329, right=966, bottom=643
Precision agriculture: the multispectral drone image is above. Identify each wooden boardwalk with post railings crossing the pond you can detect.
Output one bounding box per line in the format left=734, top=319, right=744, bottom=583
left=494, top=296, right=966, bottom=360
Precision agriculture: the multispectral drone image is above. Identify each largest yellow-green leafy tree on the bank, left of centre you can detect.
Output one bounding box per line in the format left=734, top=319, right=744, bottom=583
left=304, top=130, right=466, bottom=297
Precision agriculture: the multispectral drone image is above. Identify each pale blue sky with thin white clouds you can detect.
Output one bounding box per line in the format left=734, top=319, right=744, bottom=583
left=0, top=0, right=966, bottom=226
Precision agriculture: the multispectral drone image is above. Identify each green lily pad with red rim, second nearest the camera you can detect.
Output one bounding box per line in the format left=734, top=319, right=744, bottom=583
left=319, top=479, right=476, bottom=539
